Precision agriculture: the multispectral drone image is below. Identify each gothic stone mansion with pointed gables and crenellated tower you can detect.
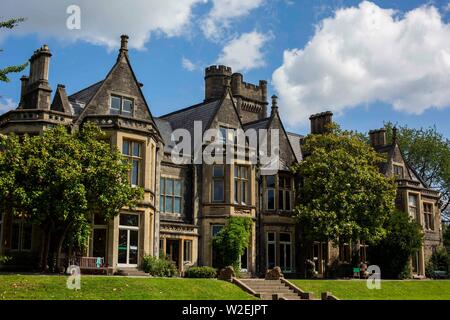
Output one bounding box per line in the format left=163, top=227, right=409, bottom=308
left=0, top=36, right=442, bottom=276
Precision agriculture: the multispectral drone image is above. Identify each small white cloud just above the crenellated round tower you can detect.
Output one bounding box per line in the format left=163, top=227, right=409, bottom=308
left=217, top=31, right=270, bottom=71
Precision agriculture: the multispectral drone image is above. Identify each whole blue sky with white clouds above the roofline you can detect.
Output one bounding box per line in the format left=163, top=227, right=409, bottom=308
left=0, top=0, right=450, bottom=138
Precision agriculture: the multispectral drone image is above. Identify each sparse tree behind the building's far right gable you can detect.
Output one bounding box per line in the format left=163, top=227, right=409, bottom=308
left=385, top=122, right=450, bottom=222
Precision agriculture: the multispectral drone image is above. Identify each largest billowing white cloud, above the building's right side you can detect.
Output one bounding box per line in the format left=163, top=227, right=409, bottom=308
left=273, top=1, right=450, bottom=125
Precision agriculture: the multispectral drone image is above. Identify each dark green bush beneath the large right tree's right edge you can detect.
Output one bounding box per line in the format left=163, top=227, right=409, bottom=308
left=370, top=211, right=423, bottom=279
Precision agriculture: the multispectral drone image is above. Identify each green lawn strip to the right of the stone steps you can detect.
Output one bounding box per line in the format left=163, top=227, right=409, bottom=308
left=292, top=280, right=450, bottom=300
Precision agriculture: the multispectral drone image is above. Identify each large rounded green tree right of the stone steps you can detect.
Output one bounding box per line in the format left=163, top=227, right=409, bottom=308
left=292, top=125, right=396, bottom=244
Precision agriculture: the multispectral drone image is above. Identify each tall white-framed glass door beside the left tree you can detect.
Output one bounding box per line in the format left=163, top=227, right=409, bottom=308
left=118, top=214, right=139, bottom=267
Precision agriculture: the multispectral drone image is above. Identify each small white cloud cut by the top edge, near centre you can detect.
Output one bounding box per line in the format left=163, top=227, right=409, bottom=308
left=202, top=0, right=264, bottom=40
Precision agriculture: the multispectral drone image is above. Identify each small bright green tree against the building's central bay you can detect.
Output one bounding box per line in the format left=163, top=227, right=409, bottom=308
left=213, top=217, right=253, bottom=272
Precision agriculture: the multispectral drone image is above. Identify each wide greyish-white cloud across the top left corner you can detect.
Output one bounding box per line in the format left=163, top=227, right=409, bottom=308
left=0, top=0, right=204, bottom=49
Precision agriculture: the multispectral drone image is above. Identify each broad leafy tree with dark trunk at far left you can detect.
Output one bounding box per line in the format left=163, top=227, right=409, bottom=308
left=0, top=124, right=143, bottom=269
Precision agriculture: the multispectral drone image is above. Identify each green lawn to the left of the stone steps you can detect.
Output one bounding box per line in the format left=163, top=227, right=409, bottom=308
left=0, top=275, right=255, bottom=300
